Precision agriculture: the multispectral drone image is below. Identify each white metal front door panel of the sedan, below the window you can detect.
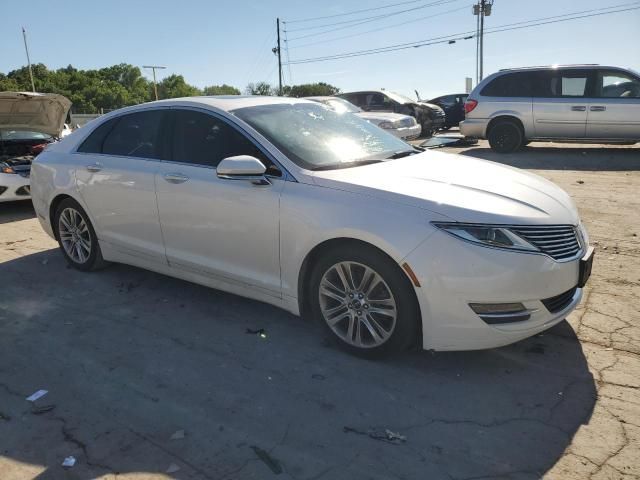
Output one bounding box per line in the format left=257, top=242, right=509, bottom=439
left=156, top=163, right=283, bottom=295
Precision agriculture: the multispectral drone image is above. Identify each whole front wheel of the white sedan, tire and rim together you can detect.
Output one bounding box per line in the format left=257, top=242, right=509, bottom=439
left=308, top=245, right=419, bottom=357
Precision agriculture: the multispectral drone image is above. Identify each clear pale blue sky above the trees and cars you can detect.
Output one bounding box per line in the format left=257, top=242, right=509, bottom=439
left=0, top=0, right=640, bottom=98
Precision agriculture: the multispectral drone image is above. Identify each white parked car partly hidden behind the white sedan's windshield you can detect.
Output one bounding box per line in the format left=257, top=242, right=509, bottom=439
left=306, top=96, right=422, bottom=140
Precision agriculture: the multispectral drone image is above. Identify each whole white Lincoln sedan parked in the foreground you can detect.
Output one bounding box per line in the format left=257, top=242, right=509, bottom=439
left=32, top=96, right=593, bottom=355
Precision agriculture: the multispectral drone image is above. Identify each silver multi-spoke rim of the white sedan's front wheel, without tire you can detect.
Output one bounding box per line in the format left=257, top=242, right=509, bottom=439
left=319, top=262, right=398, bottom=348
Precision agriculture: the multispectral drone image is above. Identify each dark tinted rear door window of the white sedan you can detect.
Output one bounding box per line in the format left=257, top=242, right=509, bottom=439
left=102, top=110, right=164, bottom=159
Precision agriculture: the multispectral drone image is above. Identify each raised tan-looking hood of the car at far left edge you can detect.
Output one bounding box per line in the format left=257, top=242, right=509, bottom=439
left=0, top=92, right=71, bottom=137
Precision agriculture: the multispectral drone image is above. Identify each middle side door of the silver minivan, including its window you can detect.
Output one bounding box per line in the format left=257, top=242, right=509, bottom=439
left=533, top=69, right=595, bottom=138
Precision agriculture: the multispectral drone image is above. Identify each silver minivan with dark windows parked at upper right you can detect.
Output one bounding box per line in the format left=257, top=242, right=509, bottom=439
left=460, top=65, right=640, bottom=153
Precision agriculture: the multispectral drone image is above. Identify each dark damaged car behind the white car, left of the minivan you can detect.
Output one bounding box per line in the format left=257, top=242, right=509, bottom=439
left=337, top=90, right=445, bottom=136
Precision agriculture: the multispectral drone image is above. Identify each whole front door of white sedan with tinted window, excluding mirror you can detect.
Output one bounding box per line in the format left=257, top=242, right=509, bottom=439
left=156, top=109, right=284, bottom=297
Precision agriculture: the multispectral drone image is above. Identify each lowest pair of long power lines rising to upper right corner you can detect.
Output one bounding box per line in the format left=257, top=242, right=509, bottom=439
left=290, top=2, right=640, bottom=65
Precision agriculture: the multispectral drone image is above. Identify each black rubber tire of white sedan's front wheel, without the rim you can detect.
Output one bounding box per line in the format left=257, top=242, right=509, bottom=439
left=306, top=245, right=420, bottom=358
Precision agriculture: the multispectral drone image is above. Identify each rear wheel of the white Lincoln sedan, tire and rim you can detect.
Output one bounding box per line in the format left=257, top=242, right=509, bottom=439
left=54, top=198, right=107, bottom=272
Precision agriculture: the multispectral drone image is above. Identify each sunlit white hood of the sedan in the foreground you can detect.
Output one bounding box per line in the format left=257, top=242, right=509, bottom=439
left=313, top=151, right=579, bottom=225
